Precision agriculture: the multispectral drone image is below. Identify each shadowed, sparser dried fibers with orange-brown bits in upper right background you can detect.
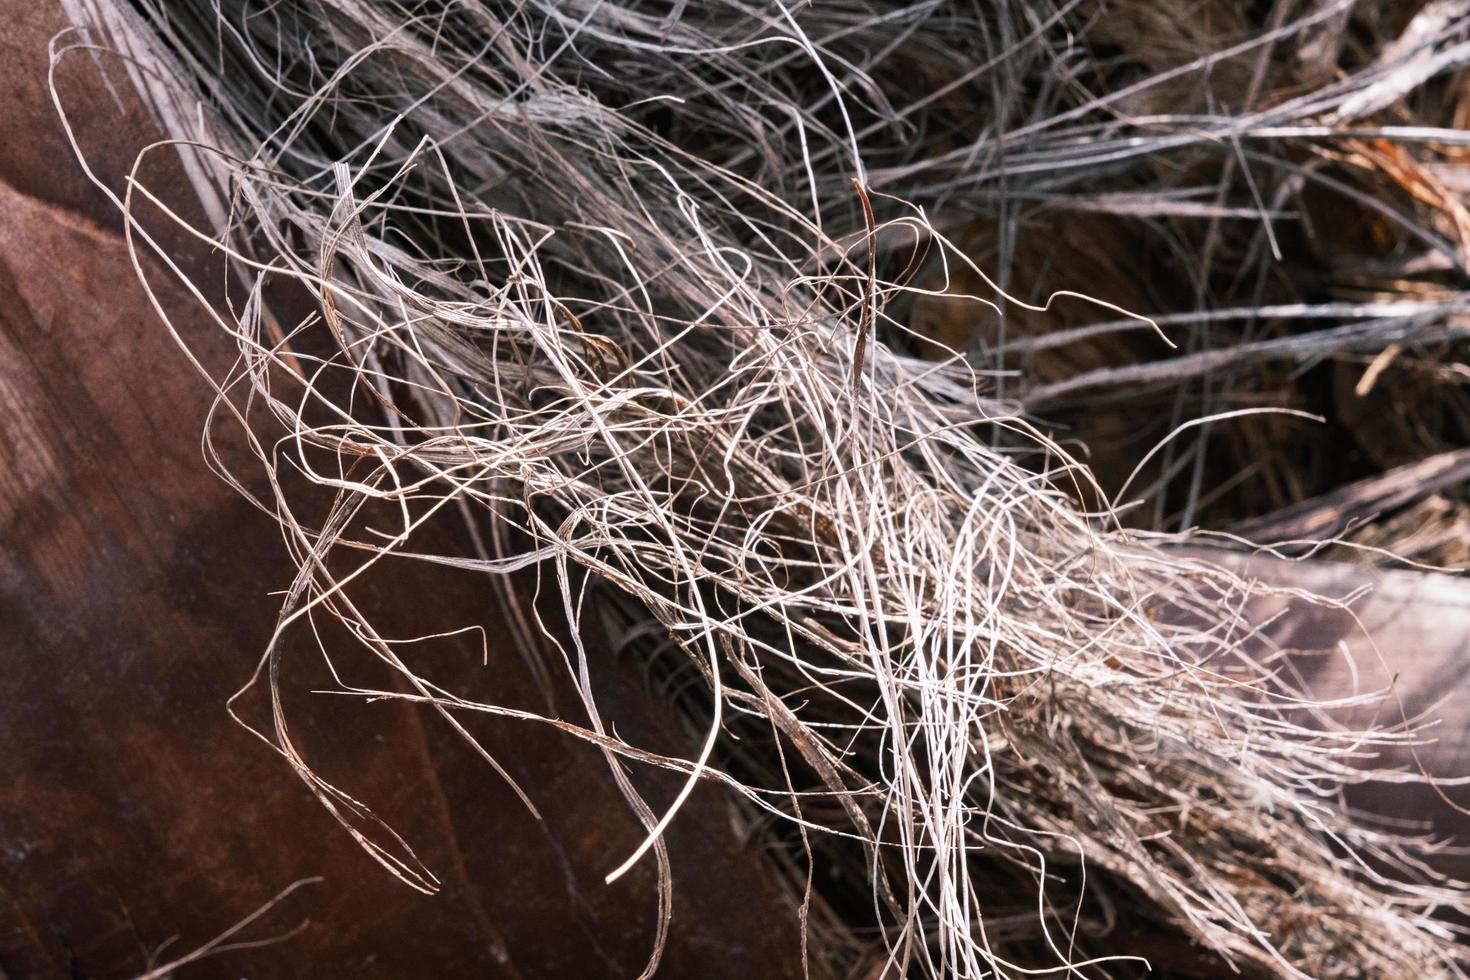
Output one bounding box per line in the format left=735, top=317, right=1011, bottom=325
left=893, top=0, right=1470, bottom=540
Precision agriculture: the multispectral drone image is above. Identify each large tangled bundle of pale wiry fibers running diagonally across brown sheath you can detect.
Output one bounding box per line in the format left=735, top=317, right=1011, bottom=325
left=54, top=0, right=1466, bottom=977
